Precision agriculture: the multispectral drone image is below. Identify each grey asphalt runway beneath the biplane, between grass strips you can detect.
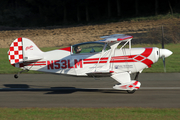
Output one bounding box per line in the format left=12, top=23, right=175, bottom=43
left=0, top=73, right=180, bottom=108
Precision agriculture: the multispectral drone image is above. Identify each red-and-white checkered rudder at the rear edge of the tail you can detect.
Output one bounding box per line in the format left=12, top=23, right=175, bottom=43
left=8, top=38, right=23, bottom=66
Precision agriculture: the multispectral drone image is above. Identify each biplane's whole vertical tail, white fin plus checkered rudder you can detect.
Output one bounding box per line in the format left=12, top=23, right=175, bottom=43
left=8, top=37, right=43, bottom=68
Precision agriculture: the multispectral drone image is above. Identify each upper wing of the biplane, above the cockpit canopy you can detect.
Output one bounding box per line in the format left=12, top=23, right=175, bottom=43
left=99, top=34, right=133, bottom=43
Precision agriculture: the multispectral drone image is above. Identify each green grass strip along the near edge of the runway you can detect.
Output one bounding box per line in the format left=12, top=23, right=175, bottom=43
left=0, top=108, right=180, bottom=120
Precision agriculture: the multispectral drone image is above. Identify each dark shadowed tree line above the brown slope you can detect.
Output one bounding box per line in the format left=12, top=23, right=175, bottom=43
left=0, top=0, right=180, bottom=26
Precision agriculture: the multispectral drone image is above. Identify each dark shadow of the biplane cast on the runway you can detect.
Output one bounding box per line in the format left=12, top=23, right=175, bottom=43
left=0, top=84, right=127, bottom=94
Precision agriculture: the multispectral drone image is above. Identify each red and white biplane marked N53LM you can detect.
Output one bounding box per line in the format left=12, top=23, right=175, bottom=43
left=8, top=34, right=172, bottom=93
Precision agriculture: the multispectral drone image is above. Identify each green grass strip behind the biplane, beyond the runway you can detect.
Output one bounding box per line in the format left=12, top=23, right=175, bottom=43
left=0, top=44, right=180, bottom=74
